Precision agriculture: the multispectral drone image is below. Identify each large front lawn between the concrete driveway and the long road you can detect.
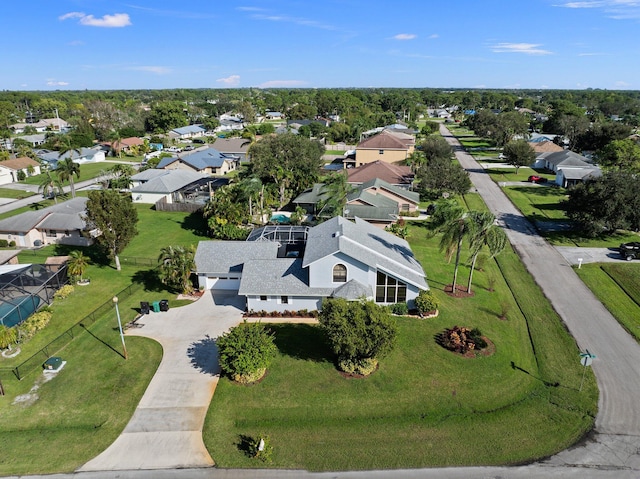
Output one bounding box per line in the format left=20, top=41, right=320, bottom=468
left=204, top=223, right=597, bottom=471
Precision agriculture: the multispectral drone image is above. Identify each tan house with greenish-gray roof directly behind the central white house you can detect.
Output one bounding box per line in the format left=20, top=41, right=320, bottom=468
left=292, top=178, right=420, bottom=227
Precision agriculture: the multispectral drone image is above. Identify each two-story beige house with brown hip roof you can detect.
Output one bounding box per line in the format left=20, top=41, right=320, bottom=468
left=352, top=130, right=416, bottom=166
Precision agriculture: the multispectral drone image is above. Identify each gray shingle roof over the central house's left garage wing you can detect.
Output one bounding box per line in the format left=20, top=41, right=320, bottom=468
left=195, top=241, right=278, bottom=273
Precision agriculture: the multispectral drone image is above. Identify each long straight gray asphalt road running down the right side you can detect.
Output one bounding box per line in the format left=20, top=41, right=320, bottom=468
left=440, top=125, right=640, bottom=475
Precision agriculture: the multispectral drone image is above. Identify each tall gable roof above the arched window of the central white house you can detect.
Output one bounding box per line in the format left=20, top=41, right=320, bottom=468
left=302, top=216, right=427, bottom=288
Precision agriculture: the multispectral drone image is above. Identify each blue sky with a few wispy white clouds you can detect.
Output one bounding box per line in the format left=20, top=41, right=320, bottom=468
left=0, top=0, right=640, bottom=90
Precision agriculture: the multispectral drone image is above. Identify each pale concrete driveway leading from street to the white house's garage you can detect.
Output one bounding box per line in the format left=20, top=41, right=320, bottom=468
left=79, top=291, right=244, bottom=471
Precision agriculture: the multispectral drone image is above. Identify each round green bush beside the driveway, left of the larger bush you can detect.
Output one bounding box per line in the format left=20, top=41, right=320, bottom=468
left=216, top=321, right=278, bottom=384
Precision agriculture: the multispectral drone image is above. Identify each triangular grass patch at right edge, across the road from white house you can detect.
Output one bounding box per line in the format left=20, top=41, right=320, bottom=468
left=575, top=263, right=640, bottom=341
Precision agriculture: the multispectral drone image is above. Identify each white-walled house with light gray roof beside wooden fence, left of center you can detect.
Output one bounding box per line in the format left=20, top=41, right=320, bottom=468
left=131, top=169, right=210, bottom=204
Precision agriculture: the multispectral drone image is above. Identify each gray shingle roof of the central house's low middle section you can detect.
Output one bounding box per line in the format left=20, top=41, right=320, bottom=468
left=238, top=258, right=333, bottom=296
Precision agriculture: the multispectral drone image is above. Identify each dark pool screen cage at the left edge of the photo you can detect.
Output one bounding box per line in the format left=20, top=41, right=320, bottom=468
left=0, top=264, right=67, bottom=326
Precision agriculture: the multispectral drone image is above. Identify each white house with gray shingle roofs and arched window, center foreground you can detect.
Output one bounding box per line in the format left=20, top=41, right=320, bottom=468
left=195, top=216, right=429, bottom=312
